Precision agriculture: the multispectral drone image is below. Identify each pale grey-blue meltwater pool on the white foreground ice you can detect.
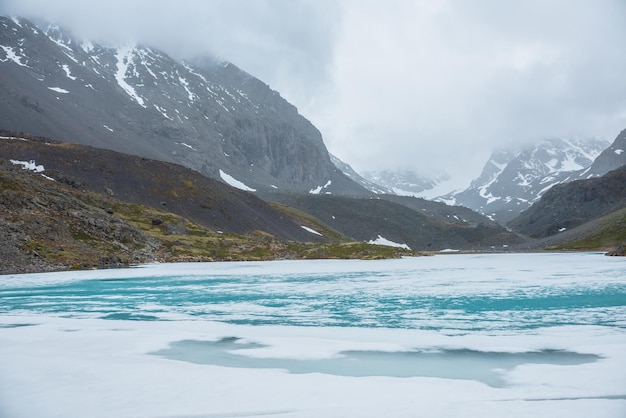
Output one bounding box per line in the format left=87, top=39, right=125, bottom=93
left=151, top=337, right=601, bottom=387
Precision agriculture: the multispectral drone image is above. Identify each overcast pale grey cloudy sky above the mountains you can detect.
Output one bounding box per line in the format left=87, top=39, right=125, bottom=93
left=0, top=0, right=626, bottom=186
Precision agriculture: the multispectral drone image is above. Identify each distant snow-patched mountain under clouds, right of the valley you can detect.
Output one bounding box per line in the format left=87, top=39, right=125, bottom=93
left=441, top=138, right=609, bottom=221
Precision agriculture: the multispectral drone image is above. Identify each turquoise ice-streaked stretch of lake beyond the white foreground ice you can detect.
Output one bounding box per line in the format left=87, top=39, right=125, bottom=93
left=0, top=254, right=626, bottom=330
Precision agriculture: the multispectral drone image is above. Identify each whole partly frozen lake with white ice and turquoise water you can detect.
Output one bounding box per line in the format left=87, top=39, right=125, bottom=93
left=0, top=253, right=626, bottom=418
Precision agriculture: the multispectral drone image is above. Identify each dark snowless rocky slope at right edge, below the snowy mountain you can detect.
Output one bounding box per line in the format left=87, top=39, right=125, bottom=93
left=509, top=166, right=626, bottom=238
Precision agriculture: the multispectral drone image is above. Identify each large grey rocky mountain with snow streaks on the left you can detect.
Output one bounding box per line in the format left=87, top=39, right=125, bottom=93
left=0, top=17, right=369, bottom=195
